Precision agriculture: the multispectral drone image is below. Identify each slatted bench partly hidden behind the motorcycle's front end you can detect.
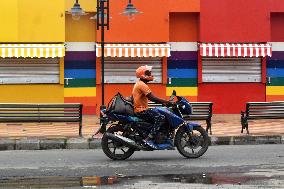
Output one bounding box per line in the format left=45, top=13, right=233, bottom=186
left=149, top=102, right=213, bottom=135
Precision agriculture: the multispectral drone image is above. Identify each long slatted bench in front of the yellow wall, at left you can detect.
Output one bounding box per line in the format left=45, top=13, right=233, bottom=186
left=0, top=103, right=83, bottom=136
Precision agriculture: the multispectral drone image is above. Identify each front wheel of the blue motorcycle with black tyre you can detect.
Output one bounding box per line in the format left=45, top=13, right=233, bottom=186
left=175, top=127, right=210, bottom=158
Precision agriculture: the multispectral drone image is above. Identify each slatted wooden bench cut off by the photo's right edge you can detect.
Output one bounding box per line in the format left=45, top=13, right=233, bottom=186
left=241, top=101, right=284, bottom=134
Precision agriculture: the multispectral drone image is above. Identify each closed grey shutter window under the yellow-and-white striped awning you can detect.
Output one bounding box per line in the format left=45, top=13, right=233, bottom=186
left=0, top=58, right=59, bottom=84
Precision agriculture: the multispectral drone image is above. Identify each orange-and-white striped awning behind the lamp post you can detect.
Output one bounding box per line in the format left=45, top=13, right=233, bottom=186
left=96, top=44, right=171, bottom=57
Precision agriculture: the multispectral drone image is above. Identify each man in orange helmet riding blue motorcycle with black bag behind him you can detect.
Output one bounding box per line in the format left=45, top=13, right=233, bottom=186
left=97, top=66, right=210, bottom=160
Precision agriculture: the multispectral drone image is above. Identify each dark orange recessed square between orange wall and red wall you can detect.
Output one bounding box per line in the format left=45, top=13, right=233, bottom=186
left=170, top=13, right=199, bottom=42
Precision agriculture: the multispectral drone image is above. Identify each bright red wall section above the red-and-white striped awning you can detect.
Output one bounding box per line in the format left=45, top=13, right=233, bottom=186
left=200, top=0, right=270, bottom=42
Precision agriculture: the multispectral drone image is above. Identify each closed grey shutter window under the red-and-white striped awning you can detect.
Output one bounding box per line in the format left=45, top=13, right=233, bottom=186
left=202, top=57, right=261, bottom=82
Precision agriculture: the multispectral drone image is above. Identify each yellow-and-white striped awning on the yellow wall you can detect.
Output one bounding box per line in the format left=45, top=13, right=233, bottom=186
left=0, top=44, right=65, bottom=58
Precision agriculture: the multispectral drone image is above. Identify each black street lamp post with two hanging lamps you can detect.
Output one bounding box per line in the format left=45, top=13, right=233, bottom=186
left=69, top=0, right=142, bottom=106
